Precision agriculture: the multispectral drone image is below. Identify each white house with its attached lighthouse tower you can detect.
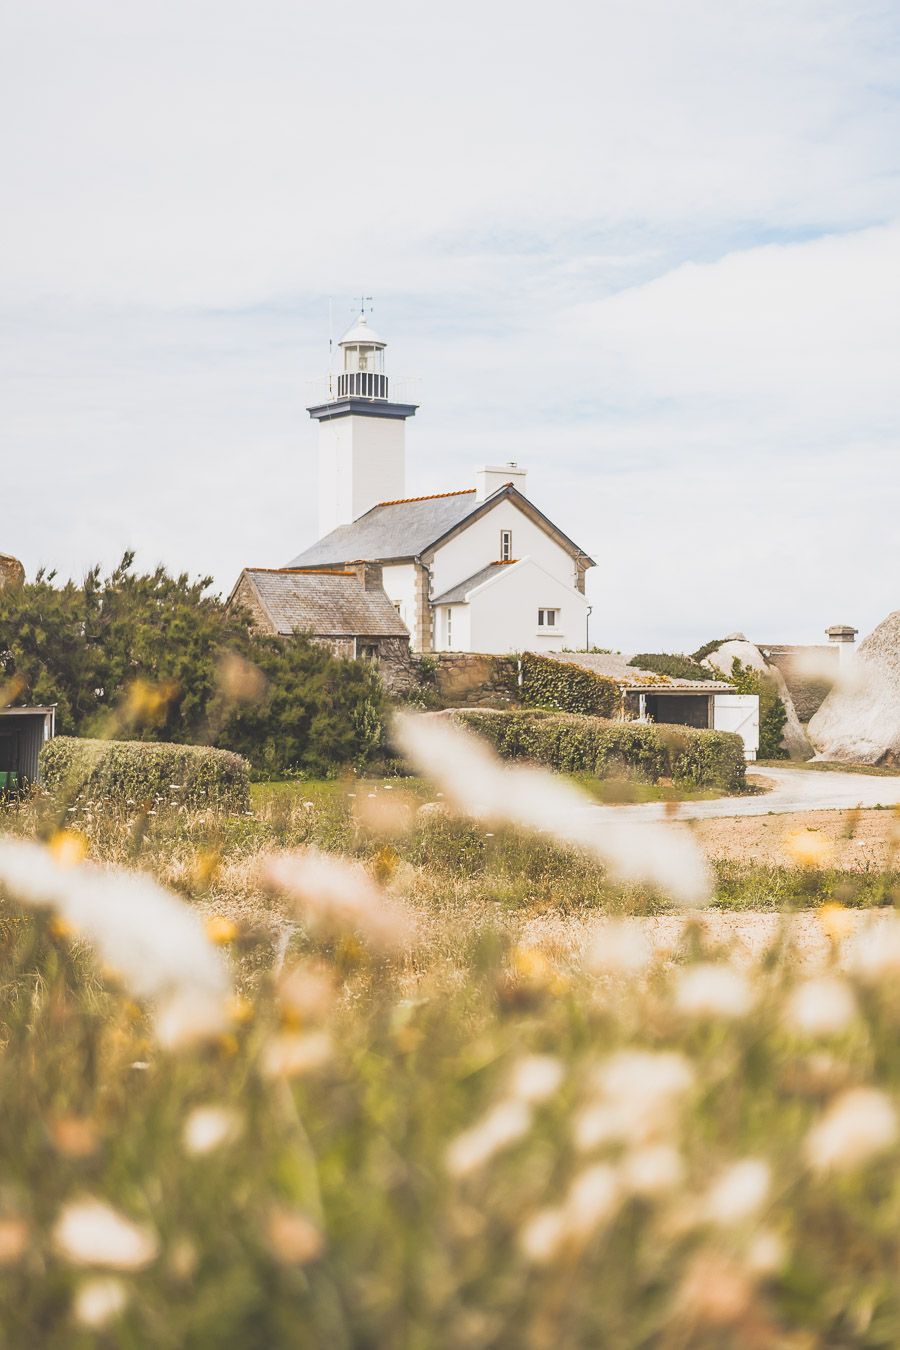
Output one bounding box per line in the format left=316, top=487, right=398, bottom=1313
left=287, top=313, right=595, bottom=652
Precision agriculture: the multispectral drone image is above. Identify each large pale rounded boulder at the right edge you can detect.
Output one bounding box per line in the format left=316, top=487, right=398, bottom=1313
left=810, top=609, right=900, bottom=765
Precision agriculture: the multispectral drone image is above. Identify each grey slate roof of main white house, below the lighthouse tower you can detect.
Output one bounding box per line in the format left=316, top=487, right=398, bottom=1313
left=287, top=487, right=480, bottom=567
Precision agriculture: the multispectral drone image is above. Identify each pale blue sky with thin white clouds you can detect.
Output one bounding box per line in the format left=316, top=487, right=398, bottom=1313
left=0, top=0, right=900, bottom=651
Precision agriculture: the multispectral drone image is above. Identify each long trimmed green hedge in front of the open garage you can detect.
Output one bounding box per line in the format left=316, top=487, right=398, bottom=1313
left=449, top=709, right=746, bottom=792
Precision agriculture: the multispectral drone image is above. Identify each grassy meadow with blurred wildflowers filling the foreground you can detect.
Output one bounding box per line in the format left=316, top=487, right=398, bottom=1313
left=0, top=734, right=900, bottom=1350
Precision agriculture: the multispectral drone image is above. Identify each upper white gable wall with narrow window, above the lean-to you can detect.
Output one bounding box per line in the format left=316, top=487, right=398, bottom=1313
left=432, top=497, right=585, bottom=596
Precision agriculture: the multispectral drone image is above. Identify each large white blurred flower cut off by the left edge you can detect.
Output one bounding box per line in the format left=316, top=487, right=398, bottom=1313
left=0, top=837, right=231, bottom=1049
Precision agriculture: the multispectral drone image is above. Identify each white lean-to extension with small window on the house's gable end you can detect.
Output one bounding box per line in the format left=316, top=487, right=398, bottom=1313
left=434, top=558, right=587, bottom=655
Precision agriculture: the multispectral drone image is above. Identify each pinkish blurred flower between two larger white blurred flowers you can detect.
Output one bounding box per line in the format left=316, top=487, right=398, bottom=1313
left=260, top=848, right=414, bottom=950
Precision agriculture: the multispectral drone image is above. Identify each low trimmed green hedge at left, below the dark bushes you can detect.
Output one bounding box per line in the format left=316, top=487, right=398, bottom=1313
left=40, top=736, right=250, bottom=811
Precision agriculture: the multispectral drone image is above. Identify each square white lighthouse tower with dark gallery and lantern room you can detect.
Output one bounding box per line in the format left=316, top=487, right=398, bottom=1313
left=306, top=312, right=416, bottom=539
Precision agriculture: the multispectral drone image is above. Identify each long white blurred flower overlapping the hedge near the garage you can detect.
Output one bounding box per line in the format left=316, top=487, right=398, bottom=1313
left=394, top=713, right=711, bottom=905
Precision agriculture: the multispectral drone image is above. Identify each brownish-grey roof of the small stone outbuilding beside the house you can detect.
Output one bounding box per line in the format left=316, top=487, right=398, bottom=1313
left=242, top=567, right=409, bottom=637
